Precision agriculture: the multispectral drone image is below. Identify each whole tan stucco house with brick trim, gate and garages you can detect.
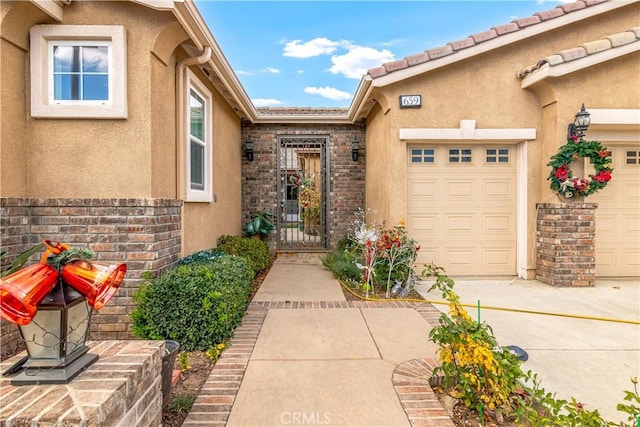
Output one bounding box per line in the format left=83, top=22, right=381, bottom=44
left=0, top=0, right=640, bottom=354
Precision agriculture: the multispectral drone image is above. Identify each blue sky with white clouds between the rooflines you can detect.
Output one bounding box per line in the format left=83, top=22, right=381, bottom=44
left=196, top=0, right=560, bottom=107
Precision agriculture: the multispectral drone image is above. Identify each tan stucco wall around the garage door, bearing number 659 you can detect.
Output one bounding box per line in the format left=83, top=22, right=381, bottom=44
left=366, top=5, right=640, bottom=271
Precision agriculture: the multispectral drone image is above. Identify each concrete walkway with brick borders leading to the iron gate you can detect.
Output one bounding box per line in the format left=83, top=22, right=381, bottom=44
left=184, top=256, right=453, bottom=427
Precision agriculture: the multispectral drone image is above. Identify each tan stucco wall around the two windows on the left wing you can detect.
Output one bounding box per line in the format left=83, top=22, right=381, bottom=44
left=0, top=2, right=242, bottom=253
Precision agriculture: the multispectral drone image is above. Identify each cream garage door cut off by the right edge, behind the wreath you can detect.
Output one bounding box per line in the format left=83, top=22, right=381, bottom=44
left=586, top=144, right=640, bottom=277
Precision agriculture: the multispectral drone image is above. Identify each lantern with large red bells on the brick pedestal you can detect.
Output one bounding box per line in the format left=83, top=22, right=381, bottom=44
left=0, top=241, right=127, bottom=385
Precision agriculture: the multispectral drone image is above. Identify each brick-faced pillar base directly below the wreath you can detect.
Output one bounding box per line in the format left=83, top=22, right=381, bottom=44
left=536, top=203, right=598, bottom=286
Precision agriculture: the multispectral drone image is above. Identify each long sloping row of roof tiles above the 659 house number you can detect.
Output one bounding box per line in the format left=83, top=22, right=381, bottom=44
left=367, top=0, right=609, bottom=79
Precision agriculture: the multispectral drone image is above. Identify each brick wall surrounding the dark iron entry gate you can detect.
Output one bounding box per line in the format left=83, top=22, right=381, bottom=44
left=242, top=122, right=366, bottom=250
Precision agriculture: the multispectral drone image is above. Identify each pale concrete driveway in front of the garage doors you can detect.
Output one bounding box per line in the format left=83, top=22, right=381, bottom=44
left=417, top=279, right=640, bottom=421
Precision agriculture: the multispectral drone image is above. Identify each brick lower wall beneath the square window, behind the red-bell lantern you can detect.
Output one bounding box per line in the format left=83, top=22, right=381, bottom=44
left=0, top=198, right=182, bottom=354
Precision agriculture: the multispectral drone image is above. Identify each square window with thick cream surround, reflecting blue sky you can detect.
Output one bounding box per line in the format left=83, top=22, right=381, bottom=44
left=30, top=25, right=127, bottom=119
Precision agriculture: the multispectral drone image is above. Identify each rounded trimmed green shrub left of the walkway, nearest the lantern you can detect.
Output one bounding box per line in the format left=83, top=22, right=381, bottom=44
left=131, top=256, right=253, bottom=351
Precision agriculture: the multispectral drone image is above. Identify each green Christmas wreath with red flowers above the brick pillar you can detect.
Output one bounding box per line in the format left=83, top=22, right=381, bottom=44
left=547, top=138, right=613, bottom=199
